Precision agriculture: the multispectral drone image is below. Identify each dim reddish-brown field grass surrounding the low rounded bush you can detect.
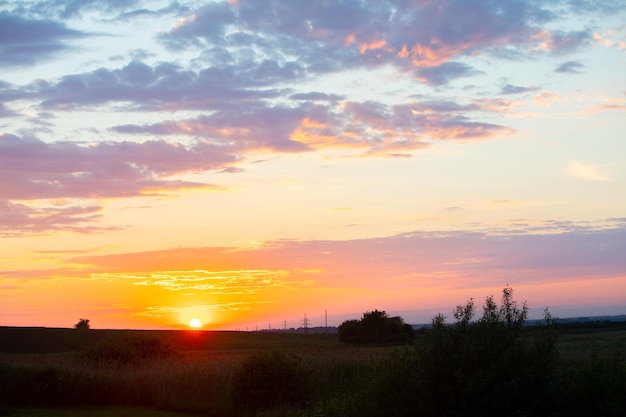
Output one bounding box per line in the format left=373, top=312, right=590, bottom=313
left=0, top=328, right=626, bottom=417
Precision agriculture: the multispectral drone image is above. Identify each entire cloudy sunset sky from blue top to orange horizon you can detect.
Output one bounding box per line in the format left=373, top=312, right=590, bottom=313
left=0, top=0, right=626, bottom=330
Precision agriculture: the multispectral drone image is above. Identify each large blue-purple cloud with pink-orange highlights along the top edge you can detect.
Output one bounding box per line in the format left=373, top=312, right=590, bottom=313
left=152, top=0, right=591, bottom=85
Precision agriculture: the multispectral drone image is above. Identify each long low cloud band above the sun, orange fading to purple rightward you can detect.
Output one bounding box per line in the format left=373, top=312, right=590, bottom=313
left=6, top=220, right=626, bottom=294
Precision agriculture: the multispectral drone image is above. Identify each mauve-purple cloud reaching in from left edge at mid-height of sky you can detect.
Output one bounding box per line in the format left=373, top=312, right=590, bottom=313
left=0, top=134, right=236, bottom=200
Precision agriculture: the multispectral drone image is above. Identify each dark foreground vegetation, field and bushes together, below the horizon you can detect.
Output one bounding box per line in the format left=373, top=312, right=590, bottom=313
left=0, top=288, right=626, bottom=417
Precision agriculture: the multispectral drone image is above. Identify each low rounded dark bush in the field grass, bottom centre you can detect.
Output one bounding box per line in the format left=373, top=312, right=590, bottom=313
left=232, top=350, right=310, bottom=410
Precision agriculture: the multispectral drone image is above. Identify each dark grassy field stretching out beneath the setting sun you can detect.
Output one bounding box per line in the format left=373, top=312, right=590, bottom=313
left=0, top=326, right=626, bottom=417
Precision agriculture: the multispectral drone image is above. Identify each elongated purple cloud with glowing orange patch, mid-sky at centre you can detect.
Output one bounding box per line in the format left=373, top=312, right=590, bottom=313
left=113, top=100, right=512, bottom=156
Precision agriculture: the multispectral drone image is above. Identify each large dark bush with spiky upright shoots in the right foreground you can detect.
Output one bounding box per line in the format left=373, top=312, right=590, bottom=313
left=366, top=287, right=556, bottom=416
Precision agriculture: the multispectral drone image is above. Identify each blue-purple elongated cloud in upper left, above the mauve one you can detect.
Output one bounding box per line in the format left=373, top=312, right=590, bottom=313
left=23, top=62, right=298, bottom=110
